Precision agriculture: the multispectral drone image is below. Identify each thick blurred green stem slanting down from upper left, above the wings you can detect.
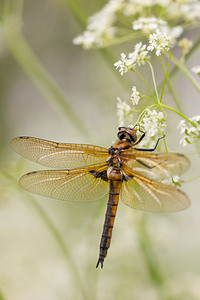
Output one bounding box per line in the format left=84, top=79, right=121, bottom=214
left=2, top=17, right=88, bottom=135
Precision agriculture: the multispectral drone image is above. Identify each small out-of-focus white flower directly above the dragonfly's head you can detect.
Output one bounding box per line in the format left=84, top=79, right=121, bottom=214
left=117, top=97, right=133, bottom=126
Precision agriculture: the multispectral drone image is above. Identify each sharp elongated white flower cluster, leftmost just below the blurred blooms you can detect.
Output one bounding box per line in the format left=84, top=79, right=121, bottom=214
left=114, top=42, right=148, bottom=75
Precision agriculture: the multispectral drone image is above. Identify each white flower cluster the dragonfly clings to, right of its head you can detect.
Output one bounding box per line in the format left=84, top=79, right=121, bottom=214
left=140, top=109, right=166, bottom=138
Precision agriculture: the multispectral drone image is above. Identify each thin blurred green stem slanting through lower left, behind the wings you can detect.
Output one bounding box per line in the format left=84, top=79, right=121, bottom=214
left=0, top=171, right=89, bottom=300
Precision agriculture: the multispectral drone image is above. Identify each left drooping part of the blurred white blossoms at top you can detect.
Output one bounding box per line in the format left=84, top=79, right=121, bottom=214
left=73, top=0, right=123, bottom=49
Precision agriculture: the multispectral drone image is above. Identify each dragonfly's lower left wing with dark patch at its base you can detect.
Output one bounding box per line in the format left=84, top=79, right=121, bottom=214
left=19, top=164, right=108, bottom=202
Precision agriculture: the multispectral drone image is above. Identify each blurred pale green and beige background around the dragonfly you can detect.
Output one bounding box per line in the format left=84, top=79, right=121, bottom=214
left=0, top=0, right=200, bottom=300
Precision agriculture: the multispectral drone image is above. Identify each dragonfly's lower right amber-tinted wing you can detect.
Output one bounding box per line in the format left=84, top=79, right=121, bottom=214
left=121, top=168, right=190, bottom=212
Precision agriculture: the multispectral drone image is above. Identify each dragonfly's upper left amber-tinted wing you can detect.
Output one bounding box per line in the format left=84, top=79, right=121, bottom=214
left=11, top=137, right=109, bottom=168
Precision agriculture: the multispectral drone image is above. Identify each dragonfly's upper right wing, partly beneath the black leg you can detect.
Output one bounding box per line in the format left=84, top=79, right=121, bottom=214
left=121, top=150, right=190, bottom=181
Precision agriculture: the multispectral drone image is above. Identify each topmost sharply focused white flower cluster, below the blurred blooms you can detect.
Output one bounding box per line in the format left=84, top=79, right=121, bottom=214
left=147, top=29, right=169, bottom=56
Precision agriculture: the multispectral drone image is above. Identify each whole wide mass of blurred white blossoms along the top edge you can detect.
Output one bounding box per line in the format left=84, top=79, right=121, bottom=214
left=74, top=0, right=200, bottom=49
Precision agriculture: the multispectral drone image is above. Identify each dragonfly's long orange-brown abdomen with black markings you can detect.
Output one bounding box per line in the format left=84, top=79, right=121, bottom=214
left=96, top=168, right=122, bottom=268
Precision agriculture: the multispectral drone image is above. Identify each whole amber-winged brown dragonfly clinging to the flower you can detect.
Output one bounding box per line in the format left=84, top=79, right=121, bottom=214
left=11, top=127, right=190, bottom=268
